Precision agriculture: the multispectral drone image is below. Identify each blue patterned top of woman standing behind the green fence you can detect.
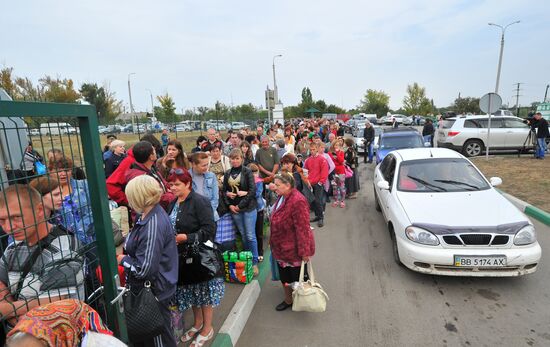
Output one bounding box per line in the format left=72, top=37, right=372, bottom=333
left=55, top=178, right=95, bottom=245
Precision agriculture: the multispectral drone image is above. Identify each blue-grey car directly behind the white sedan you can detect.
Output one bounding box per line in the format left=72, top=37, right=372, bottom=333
left=374, top=128, right=431, bottom=164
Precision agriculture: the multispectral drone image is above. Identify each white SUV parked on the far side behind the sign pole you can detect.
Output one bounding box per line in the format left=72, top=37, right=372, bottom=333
left=437, top=115, right=533, bottom=157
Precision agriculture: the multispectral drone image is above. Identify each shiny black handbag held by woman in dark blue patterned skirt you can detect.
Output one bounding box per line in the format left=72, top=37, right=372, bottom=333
left=178, top=241, right=223, bottom=285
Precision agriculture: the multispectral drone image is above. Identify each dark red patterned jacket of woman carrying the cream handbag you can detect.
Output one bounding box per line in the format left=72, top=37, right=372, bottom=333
left=269, top=190, right=316, bottom=263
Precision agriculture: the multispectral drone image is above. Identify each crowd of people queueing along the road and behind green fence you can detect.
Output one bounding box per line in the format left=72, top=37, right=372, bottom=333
left=0, top=119, right=366, bottom=346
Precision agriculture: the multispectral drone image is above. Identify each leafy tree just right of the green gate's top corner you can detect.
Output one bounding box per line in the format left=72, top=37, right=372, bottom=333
left=79, top=83, right=122, bottom=124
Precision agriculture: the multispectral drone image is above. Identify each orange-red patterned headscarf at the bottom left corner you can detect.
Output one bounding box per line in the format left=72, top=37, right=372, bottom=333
left=8, top=299, right=113, bottom=347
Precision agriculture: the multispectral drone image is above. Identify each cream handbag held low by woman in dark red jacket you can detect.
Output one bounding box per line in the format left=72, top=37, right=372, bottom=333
left=292, top=260, right=328, bottom=312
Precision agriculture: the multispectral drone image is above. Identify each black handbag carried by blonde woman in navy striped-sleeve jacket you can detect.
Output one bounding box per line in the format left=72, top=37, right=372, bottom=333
left=123, top=281, right=165, bottom=342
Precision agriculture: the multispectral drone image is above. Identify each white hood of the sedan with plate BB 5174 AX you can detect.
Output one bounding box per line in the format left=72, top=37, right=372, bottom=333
left=397, top=189, right=529, bottom=227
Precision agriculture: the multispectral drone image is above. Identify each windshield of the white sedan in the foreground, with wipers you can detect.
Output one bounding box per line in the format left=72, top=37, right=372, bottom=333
left=397, top=158, right=489, bottom=192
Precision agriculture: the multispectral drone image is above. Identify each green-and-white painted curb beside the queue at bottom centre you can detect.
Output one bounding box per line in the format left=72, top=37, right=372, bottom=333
left=211, top=249, right=271, bottom=347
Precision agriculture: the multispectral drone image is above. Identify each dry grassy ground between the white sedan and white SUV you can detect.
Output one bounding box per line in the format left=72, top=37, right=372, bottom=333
left=472, top=155, right=550, bottom=212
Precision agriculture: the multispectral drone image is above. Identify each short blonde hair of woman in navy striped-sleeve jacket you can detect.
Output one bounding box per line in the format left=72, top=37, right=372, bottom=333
left=124, top=175, right=162, bottom=213
